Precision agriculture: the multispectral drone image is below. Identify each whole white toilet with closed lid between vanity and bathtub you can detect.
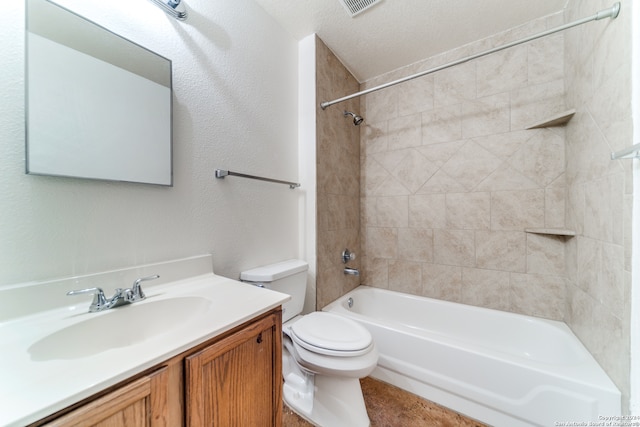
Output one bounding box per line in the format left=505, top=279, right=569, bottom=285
left=240, top=260, right=378, bottom=427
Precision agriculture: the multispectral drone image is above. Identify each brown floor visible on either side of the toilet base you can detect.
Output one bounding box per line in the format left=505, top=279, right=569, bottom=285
left=282, top=377, right=485, bottom=427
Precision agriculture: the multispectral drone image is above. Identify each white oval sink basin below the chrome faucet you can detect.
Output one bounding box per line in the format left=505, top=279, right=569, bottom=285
left=28, top=297, right=211, bottom=361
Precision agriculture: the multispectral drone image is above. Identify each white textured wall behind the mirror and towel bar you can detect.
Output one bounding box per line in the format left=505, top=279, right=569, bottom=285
left=0, top=0, right=302, bottom=286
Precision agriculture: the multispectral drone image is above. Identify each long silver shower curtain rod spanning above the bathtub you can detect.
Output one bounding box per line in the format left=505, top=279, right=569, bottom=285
left=320, top=2, right=620, bottom=110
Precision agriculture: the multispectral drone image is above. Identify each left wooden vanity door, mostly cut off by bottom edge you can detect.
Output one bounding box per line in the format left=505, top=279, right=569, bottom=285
left=45, top=367, right=172, bottom=427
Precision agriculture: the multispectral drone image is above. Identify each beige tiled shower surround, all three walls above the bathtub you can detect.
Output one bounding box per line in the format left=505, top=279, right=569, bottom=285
left=317, top=4, right=632, bottom=412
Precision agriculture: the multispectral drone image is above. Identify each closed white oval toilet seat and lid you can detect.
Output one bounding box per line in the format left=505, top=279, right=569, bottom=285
left=289, top=311, right=373, bottom=357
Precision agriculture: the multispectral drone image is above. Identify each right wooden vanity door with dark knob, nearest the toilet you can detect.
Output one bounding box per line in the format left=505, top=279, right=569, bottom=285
left=185, top=311, right=282, bottom=427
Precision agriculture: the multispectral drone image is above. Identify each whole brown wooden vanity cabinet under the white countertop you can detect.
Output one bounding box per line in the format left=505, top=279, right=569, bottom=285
left=31, top=308, right=282, bottom=427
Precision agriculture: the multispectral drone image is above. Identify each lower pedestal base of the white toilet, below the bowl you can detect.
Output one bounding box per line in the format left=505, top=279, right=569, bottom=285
left=283, top=364, right=370, bottom=427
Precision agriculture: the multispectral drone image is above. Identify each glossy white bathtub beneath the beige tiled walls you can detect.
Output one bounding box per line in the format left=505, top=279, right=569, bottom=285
left=324, top=286, right=620, bottom=427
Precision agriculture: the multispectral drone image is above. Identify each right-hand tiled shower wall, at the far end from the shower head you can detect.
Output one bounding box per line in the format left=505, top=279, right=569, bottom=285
left=565, top=0, right=637, bottom=412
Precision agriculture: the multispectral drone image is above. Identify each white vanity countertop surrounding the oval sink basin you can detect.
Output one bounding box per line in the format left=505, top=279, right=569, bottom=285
left=0, top=273, right=289, bottom=426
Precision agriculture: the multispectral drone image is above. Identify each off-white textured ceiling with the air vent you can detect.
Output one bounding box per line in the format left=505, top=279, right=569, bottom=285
left=255, top=0, right=566, bottom=82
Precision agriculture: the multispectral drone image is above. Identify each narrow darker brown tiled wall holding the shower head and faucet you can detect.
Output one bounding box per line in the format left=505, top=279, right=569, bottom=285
left=316, top=37, right=360, bottom=309
